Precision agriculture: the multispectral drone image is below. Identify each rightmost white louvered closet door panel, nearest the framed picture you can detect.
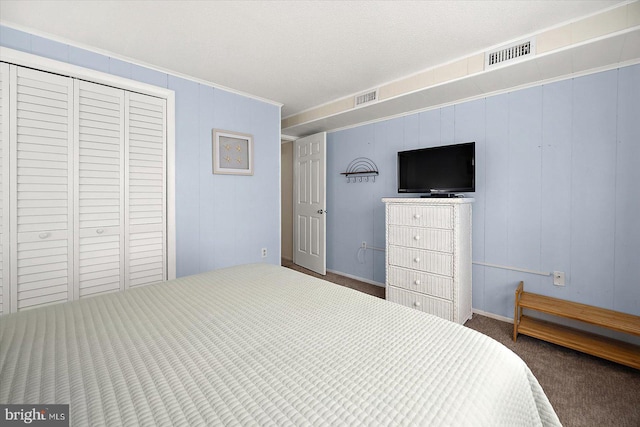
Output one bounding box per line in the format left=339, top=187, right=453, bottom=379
left=125, top=92, right=167, bottom=287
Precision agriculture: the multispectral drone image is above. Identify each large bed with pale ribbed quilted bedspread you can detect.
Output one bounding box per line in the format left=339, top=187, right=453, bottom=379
left=0, top=264, right=560, bottom=426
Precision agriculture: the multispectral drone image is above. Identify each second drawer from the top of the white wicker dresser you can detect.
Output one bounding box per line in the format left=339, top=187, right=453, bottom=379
left=387, top=225, right=453, bottom=253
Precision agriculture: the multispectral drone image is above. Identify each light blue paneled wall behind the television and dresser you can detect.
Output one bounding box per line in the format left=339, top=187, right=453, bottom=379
left=327, top=65, right=640, bottom=317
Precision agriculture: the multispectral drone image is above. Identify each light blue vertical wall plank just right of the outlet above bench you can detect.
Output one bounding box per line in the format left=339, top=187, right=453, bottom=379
left=570, top=70, right=618, bottom=308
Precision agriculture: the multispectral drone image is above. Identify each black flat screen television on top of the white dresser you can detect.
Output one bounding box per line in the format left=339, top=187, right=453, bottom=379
left=398, top=142, right=476, bottom=197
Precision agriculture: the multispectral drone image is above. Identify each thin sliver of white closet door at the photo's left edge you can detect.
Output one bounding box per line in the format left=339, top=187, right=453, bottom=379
left=0, top=63, right=10, bottom=315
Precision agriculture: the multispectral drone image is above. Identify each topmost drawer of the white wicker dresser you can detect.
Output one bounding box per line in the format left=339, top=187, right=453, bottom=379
left=387, top=204, right=453, bottom=230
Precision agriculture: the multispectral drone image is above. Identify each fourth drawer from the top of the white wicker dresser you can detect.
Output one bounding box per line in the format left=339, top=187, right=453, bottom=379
left=387, top=266, right=453, bottom=300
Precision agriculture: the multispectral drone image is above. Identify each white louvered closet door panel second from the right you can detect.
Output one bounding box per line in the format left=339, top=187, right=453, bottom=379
left=74, top=81, right=125, bottom=298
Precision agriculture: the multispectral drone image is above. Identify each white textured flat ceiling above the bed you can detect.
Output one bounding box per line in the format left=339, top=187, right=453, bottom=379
left=0, top=0, right=622, bottom=117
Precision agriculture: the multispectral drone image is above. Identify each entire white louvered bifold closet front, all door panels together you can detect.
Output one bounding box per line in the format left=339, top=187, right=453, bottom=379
left=0, top=63, right=167, bottom=314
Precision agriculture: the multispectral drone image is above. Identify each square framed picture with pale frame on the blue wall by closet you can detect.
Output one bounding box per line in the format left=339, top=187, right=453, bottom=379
left=212, top=129, right=253, bottom=175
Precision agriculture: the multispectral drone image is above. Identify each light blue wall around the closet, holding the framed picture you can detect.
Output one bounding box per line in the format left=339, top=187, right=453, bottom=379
left=0, top=26, right=280, bottom=277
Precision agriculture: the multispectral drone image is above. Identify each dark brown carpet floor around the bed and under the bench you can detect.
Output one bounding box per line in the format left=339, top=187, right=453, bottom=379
left=282, top=260, right=640, bottom=427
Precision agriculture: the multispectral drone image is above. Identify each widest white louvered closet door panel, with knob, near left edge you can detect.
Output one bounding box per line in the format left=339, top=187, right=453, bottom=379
left=10, top=65, right=73, bottom=311
